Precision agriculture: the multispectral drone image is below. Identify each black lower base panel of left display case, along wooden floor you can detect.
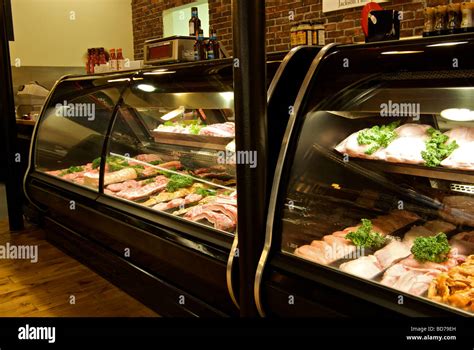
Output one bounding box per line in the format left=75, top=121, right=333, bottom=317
left=45, top=217, right=226, bottom=317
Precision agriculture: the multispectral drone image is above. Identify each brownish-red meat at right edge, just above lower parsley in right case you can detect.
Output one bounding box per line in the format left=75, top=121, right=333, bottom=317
left=439, top=196, right=474, bottom=226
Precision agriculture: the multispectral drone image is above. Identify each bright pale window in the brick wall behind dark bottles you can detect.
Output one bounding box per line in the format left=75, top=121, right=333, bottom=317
left=163, top=0, right=209, bottom=37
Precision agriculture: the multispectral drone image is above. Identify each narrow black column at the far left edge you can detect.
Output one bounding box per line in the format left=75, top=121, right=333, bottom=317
left=0, top=0, right=27, bottom=231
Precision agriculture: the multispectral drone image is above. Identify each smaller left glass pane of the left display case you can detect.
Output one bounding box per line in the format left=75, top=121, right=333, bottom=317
left=34, top=78, right=127, bottom=190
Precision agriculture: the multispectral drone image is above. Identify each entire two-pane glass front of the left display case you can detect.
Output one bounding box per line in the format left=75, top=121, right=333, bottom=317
left=35, top=66, right=237, bottom=233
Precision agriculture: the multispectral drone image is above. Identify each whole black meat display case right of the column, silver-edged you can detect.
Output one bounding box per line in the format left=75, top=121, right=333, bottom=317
left=255, top=34, right=474, bottom=317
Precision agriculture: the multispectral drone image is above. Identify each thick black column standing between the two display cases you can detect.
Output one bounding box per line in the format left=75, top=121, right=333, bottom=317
left=232, top=0, right=267, bottom=317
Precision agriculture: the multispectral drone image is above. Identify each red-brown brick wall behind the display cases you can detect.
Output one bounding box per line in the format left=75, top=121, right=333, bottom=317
left=132, top=0, right=466, bottom=59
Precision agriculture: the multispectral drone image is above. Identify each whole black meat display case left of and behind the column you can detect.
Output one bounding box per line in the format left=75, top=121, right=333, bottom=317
left=25, top=47, right=320, bottom=316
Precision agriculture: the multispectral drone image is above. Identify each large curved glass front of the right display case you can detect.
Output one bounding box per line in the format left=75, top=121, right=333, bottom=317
left=277, top=40, right=474, bottom=314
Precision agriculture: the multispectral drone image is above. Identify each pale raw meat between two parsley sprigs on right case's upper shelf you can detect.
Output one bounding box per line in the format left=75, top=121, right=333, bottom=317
left=385, top=137, right=427, bottom=164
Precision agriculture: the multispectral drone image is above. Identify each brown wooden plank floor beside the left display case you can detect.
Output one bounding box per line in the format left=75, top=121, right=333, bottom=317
left=0, top=221, right=158, bottom=317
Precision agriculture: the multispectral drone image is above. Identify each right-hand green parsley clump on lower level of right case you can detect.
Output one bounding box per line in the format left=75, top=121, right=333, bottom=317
left=411, top=232, right=451, bottom=263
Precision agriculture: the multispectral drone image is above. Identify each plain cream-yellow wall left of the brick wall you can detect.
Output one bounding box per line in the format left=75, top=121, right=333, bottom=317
left=10, top=0, right=133, bottom=67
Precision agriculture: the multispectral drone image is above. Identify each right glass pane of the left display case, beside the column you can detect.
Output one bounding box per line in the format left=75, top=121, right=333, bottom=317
left=104, top=65, right=237, bottom=234
